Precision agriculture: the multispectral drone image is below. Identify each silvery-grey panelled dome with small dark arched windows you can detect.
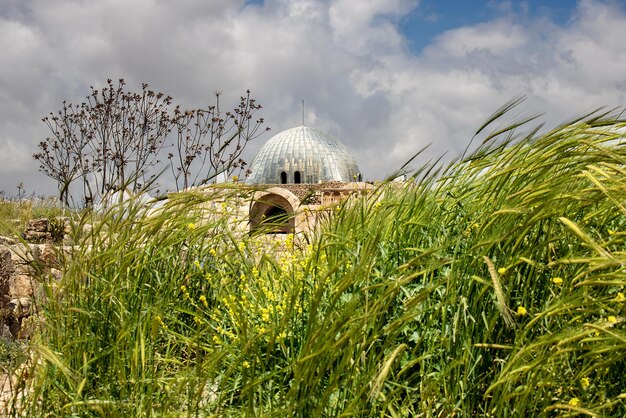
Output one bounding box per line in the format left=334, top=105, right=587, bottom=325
left=246, top=126, right=360, bottom=184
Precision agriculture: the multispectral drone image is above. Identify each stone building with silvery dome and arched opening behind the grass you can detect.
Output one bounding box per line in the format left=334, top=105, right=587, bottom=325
left=245, top=125, right=373, bottom=233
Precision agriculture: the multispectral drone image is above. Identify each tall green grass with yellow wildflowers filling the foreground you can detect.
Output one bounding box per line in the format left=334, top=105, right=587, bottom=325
left=4, top=108, right=626, bottom=417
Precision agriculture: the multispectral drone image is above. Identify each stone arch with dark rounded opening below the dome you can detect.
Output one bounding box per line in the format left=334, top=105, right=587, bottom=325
left=249, top=187, right=300, bottom=234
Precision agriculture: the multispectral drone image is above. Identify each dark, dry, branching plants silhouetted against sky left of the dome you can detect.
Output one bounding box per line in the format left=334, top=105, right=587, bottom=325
left=33, top=79, right=263, bottom=206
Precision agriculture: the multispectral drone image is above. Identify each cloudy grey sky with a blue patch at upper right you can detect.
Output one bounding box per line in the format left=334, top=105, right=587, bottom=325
left=0, top=0, right=626, bottom=194
